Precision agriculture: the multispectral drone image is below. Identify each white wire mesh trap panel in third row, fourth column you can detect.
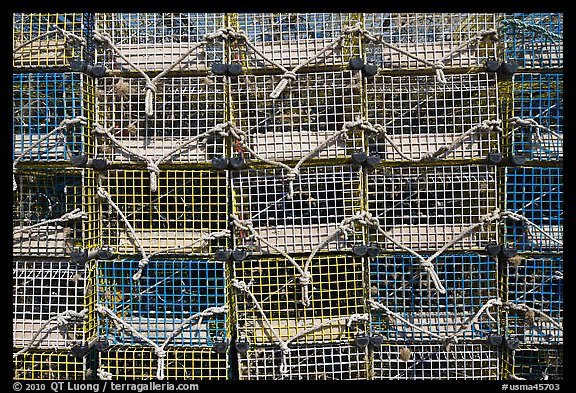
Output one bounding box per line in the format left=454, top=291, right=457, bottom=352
left=367, top=165, right=497, bottom=251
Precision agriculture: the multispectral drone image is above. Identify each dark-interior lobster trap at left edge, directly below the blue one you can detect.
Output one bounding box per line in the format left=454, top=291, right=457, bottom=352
left=12, top=168, right=100, bottom=257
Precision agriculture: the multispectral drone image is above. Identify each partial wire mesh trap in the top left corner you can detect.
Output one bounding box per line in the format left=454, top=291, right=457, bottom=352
left=12, top=13, right=94, bottom=70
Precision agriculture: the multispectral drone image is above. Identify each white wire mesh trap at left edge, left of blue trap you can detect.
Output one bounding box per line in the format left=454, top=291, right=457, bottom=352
left=12, top=258, right=95, bottom=348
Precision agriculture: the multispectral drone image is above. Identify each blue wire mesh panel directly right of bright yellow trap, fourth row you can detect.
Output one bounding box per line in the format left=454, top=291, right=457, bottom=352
left=370, top=254, right=499, bottom=341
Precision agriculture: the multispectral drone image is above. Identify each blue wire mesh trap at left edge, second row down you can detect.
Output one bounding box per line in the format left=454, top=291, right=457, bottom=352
left=12, top=72, right=94, bottom=161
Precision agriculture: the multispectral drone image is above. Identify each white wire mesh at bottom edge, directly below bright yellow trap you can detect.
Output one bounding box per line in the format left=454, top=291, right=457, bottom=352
left=238, top=344, right=368, bottom=380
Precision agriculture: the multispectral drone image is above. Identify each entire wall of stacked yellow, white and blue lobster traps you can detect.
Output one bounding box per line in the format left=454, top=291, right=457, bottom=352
left=13, top=13, right=563, bottom=380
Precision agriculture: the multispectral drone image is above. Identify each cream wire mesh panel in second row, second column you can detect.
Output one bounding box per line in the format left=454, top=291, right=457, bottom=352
left=96, top=77, right=226, bottom=162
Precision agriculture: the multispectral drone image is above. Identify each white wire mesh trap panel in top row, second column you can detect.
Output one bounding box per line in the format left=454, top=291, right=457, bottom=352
left=96, top=13, right=225, bottom=71
